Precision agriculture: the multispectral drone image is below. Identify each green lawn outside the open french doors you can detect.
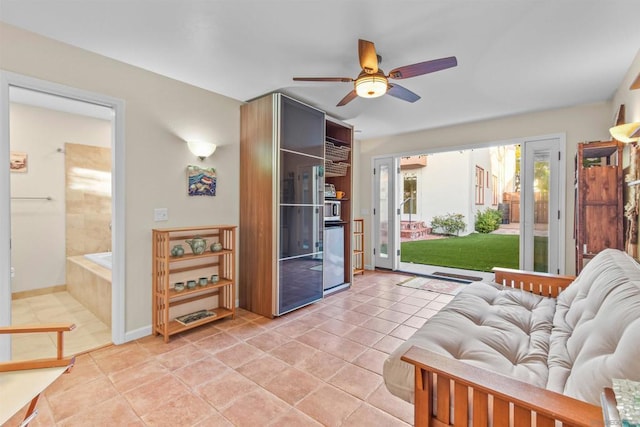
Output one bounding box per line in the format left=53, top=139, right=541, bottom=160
left=401, top=233, right=520, bottom=271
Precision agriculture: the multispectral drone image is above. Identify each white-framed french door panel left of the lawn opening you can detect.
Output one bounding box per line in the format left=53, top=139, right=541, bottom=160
left=373, top=157, right=400, bottom=270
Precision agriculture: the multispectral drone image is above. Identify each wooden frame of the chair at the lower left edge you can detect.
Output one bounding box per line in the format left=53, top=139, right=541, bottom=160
left=0, top=323, right=76, bottom=372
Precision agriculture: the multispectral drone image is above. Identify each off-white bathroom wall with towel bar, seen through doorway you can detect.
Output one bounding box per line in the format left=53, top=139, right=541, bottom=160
left=9, top=103, right=111, bottom=292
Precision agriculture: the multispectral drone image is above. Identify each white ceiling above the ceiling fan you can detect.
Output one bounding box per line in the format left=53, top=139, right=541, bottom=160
left=0, top=0, right=640, bottom=139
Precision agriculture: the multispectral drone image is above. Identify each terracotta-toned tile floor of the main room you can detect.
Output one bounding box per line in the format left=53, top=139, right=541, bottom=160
left=8, top=271, right=452, bottom=427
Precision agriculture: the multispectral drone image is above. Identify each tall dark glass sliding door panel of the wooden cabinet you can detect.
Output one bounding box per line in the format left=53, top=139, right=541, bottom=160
left=277, top=96, right=325, bottom=314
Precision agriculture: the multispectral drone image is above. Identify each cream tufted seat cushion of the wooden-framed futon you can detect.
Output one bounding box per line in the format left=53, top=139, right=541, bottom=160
left=383, top=282, right=556, bottom=402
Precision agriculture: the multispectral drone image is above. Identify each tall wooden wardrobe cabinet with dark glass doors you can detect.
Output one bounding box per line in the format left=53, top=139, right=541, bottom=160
left=238, top=93, right=353, bottom=317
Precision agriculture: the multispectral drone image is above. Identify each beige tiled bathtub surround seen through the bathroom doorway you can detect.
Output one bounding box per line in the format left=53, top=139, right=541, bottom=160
left=66, top=252, right=111, bottom=326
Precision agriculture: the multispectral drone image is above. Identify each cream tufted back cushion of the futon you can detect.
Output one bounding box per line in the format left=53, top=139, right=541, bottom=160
left=547, top=249, right=640, bottom=405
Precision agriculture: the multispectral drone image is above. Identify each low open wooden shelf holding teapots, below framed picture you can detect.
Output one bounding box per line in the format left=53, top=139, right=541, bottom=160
left=152, top=225, right=237, bottom=342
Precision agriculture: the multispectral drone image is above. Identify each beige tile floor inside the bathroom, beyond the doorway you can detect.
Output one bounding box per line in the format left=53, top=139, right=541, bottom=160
left=11, top=291, right=111, bottom=360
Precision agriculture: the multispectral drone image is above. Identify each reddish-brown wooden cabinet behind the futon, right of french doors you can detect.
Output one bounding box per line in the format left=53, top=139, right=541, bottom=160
left=575, top=140, right=624, bottom=274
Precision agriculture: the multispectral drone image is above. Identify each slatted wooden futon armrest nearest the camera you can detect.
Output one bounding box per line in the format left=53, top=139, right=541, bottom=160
left=402, top=346, right=603, bottom=427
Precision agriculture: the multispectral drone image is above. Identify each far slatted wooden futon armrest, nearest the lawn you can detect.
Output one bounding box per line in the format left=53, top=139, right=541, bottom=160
left=493, top=267, right=575, bottom=298
